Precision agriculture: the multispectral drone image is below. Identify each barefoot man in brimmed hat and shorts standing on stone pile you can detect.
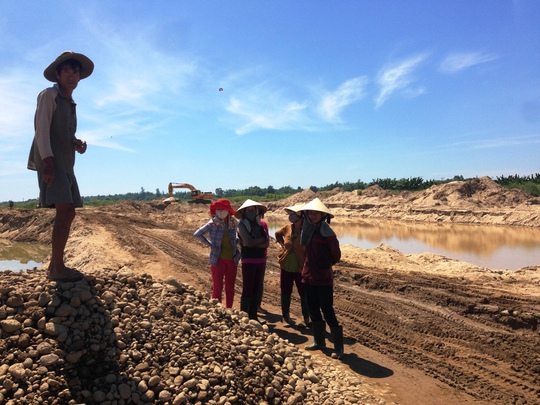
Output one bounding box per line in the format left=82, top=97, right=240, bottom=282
left=28, top=51, right=94, bottom=281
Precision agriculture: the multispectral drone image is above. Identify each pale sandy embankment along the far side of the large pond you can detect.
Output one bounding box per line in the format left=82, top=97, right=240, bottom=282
left=264, top=177, right=540, bottom=226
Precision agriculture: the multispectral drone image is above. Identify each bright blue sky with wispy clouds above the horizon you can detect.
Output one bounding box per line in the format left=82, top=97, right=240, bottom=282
left=0, top=0, right=540, bottom=201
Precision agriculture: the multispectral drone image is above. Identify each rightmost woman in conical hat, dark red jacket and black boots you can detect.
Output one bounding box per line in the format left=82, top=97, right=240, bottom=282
left=300, top=198, right=343, bottom=359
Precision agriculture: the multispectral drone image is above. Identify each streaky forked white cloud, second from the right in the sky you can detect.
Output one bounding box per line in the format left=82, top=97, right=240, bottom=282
left=375, top=54, right=426, bottom=108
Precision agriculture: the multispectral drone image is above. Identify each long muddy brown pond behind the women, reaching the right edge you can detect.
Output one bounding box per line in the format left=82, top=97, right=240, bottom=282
left=269, top=221, right=540, bottom=270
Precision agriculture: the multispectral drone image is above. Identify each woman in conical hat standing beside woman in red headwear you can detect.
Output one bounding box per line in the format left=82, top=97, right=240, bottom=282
left=235, top=199, right=269, bottom=320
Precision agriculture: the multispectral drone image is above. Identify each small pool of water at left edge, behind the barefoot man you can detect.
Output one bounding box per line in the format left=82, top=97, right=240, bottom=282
left=0, top=239, right=50, bottom=271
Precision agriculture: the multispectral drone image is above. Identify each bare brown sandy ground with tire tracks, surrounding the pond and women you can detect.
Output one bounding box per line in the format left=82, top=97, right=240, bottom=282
left=0, top=178, right=540, bottom=405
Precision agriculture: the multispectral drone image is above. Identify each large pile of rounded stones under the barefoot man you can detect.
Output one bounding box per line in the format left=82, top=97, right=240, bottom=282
left=0, top=270, right=384, bottom=405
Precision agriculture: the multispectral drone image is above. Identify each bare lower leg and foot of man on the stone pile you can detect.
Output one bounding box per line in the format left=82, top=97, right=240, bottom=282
left=47, top=204, right=83, bottom=281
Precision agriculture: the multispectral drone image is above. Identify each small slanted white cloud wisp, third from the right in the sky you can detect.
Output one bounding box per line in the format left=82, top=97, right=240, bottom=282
left=318, top=77, right=368, bottom=121
